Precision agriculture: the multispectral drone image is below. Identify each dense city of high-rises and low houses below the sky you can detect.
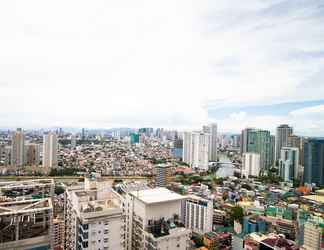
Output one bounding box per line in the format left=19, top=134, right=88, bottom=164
left=0, top=123, right=324, bottom=250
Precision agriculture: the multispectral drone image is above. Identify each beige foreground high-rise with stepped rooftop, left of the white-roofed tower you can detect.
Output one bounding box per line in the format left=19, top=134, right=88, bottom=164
left=64, top=177, right=125, bottom=250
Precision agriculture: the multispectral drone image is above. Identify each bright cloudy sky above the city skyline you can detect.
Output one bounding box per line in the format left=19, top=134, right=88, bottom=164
left=0, top=0, right=324, bottom=136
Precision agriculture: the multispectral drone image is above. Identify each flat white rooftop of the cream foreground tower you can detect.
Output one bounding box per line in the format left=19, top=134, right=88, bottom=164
left=131, top=188, right=185, bottom=204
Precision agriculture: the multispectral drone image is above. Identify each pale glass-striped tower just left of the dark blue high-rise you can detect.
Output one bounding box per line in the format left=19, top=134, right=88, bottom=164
left=279, top=147, right=299, bottom=181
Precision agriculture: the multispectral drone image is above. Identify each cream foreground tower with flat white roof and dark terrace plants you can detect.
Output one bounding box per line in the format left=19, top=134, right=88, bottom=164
left=125, top=188, right=191, bottom=250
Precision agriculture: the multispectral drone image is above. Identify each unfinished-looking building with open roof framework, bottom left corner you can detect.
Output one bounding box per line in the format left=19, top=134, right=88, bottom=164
left=0, top=179, right=54, bottom=250
